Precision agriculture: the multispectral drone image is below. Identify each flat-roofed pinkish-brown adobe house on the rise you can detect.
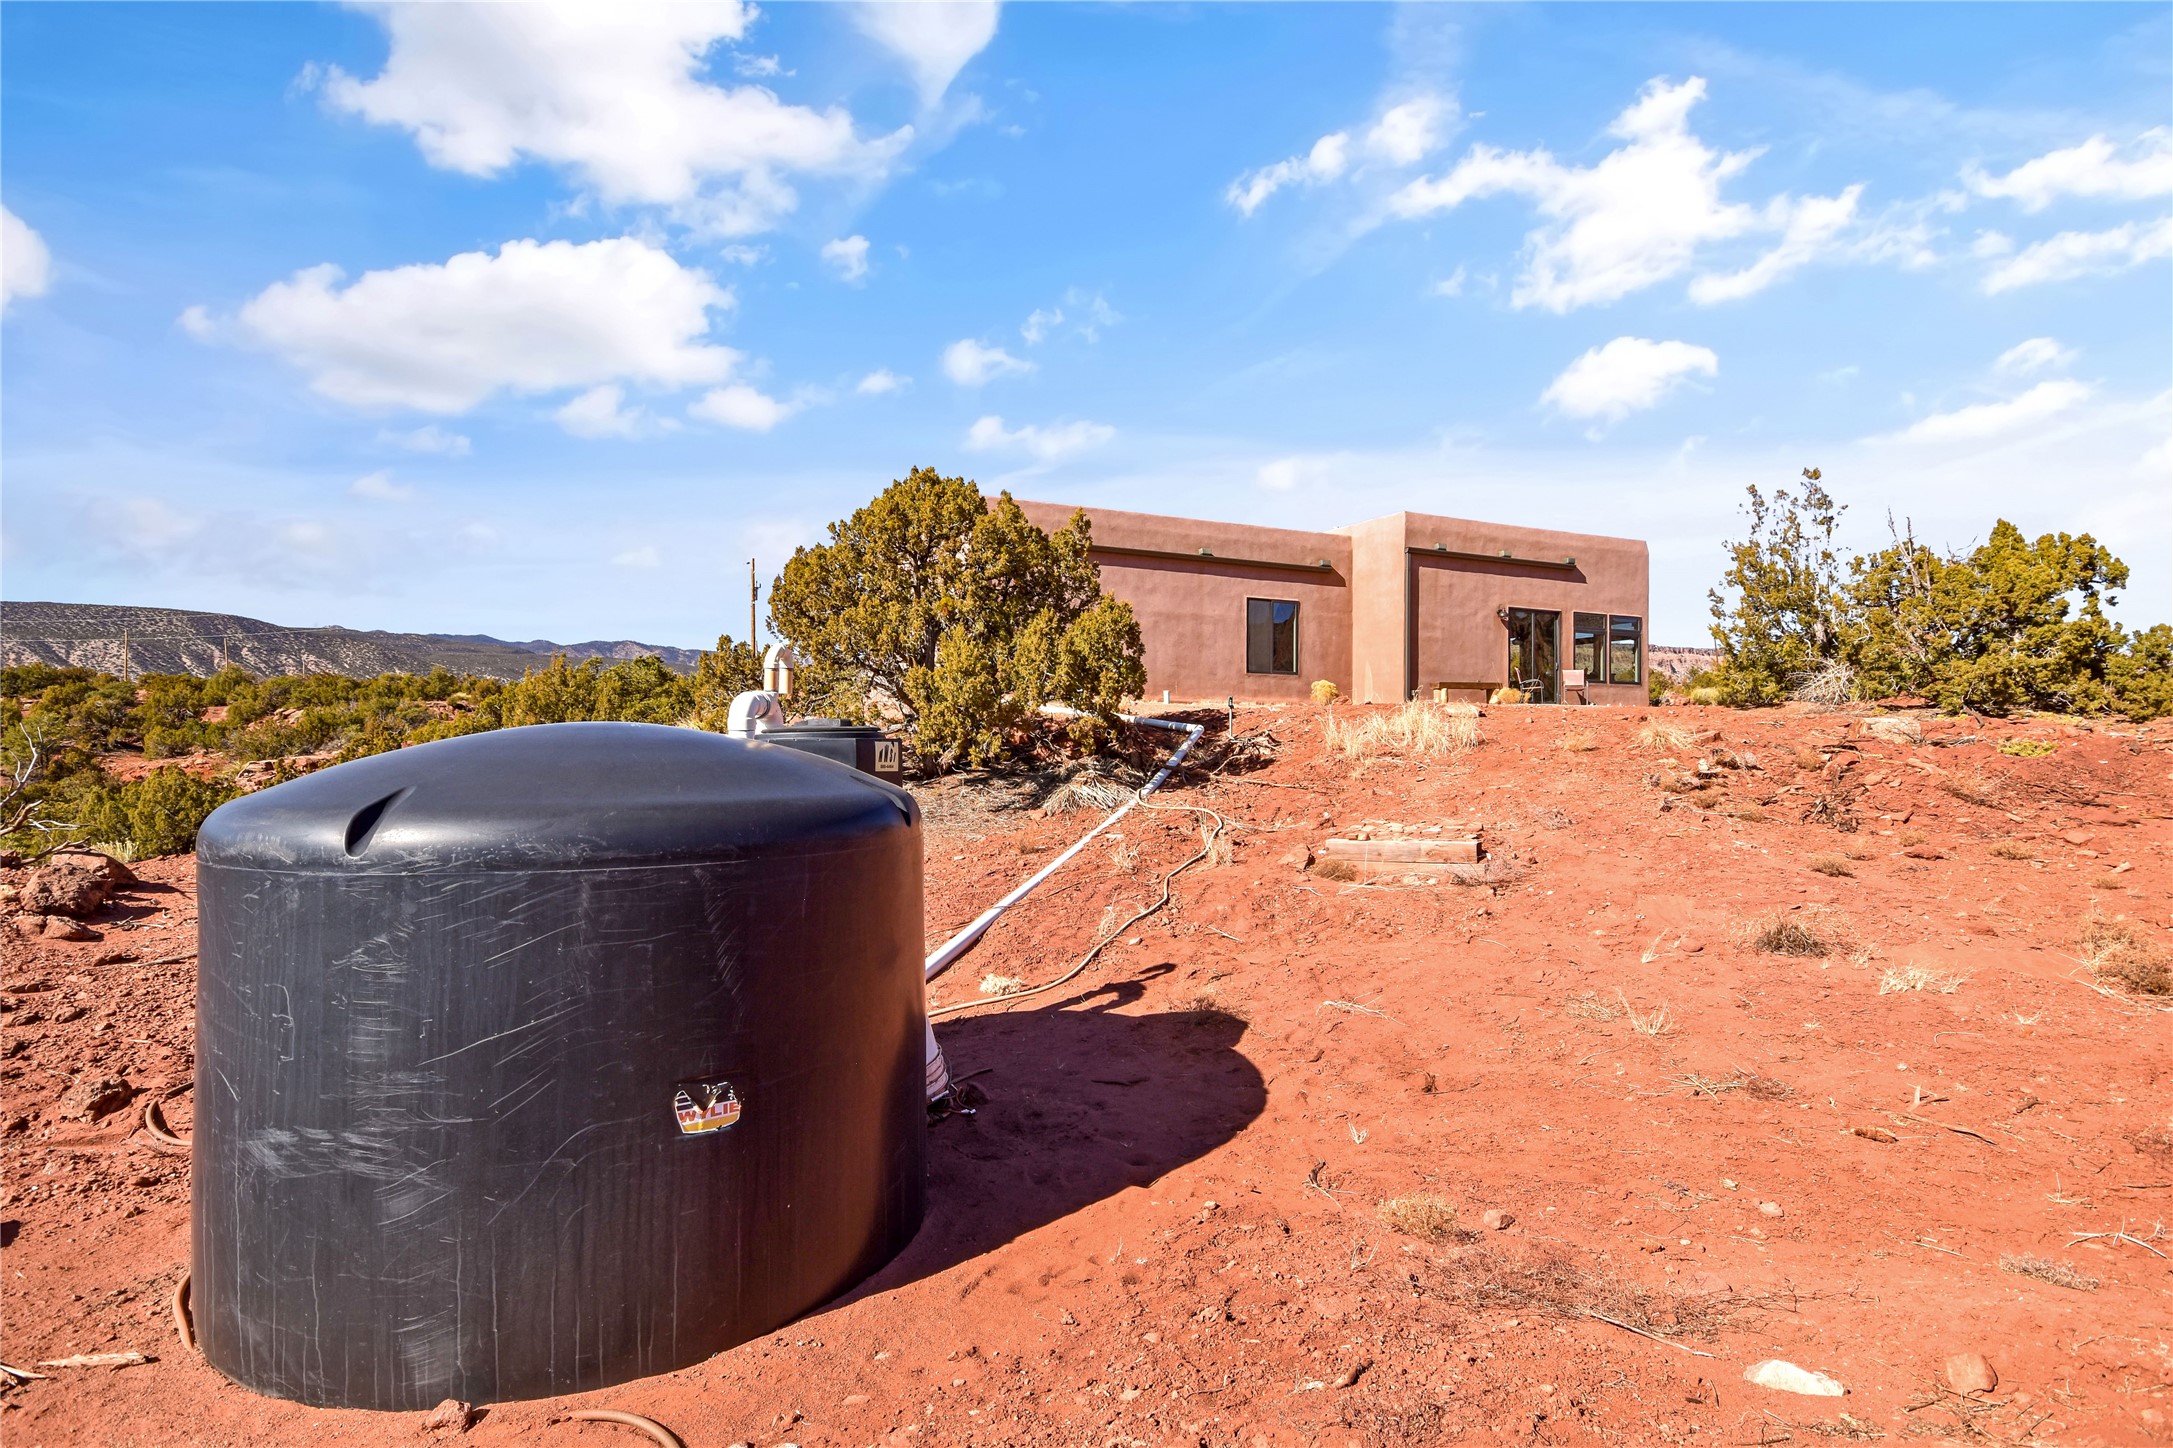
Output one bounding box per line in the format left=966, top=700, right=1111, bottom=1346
left=1019, top=500, right=1649, bottom=704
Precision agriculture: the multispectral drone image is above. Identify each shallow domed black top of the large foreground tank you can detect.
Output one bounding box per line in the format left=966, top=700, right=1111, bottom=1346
left=196, top=724, right=919, bottom=874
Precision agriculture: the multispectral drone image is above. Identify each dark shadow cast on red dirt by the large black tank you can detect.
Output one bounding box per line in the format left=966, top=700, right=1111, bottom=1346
left=832, top=968, right=1267, bottom=1307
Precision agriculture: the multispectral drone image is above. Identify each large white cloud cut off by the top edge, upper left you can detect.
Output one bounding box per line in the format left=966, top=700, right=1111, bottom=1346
left=322, top=0, right=913, bottom=235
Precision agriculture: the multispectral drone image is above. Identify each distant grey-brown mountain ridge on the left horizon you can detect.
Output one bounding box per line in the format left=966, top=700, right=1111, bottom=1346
left=0, top=602, right=704, bottom=678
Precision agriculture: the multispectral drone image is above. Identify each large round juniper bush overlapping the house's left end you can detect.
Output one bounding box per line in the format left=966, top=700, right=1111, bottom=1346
left=769, top=467, right=1147, bottom=765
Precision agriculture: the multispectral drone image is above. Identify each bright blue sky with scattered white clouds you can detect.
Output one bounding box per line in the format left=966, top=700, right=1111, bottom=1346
left=0, top=4, right=2173, bottom=644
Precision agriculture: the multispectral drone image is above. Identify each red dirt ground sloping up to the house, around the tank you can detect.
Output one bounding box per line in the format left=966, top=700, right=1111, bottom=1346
left=0, top=709, right=2173, bottom=1448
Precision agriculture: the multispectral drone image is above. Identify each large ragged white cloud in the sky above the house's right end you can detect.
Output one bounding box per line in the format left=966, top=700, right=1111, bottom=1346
left=1389, top=76, right=1860, bottom=311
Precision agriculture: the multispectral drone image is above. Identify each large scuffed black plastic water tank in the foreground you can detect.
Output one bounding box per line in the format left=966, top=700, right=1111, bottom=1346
left=191, top=724, right=926, bottom=1409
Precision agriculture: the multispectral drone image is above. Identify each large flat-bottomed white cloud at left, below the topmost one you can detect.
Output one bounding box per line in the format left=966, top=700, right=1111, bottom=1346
left=214, top=237, right=739, bottom=413
